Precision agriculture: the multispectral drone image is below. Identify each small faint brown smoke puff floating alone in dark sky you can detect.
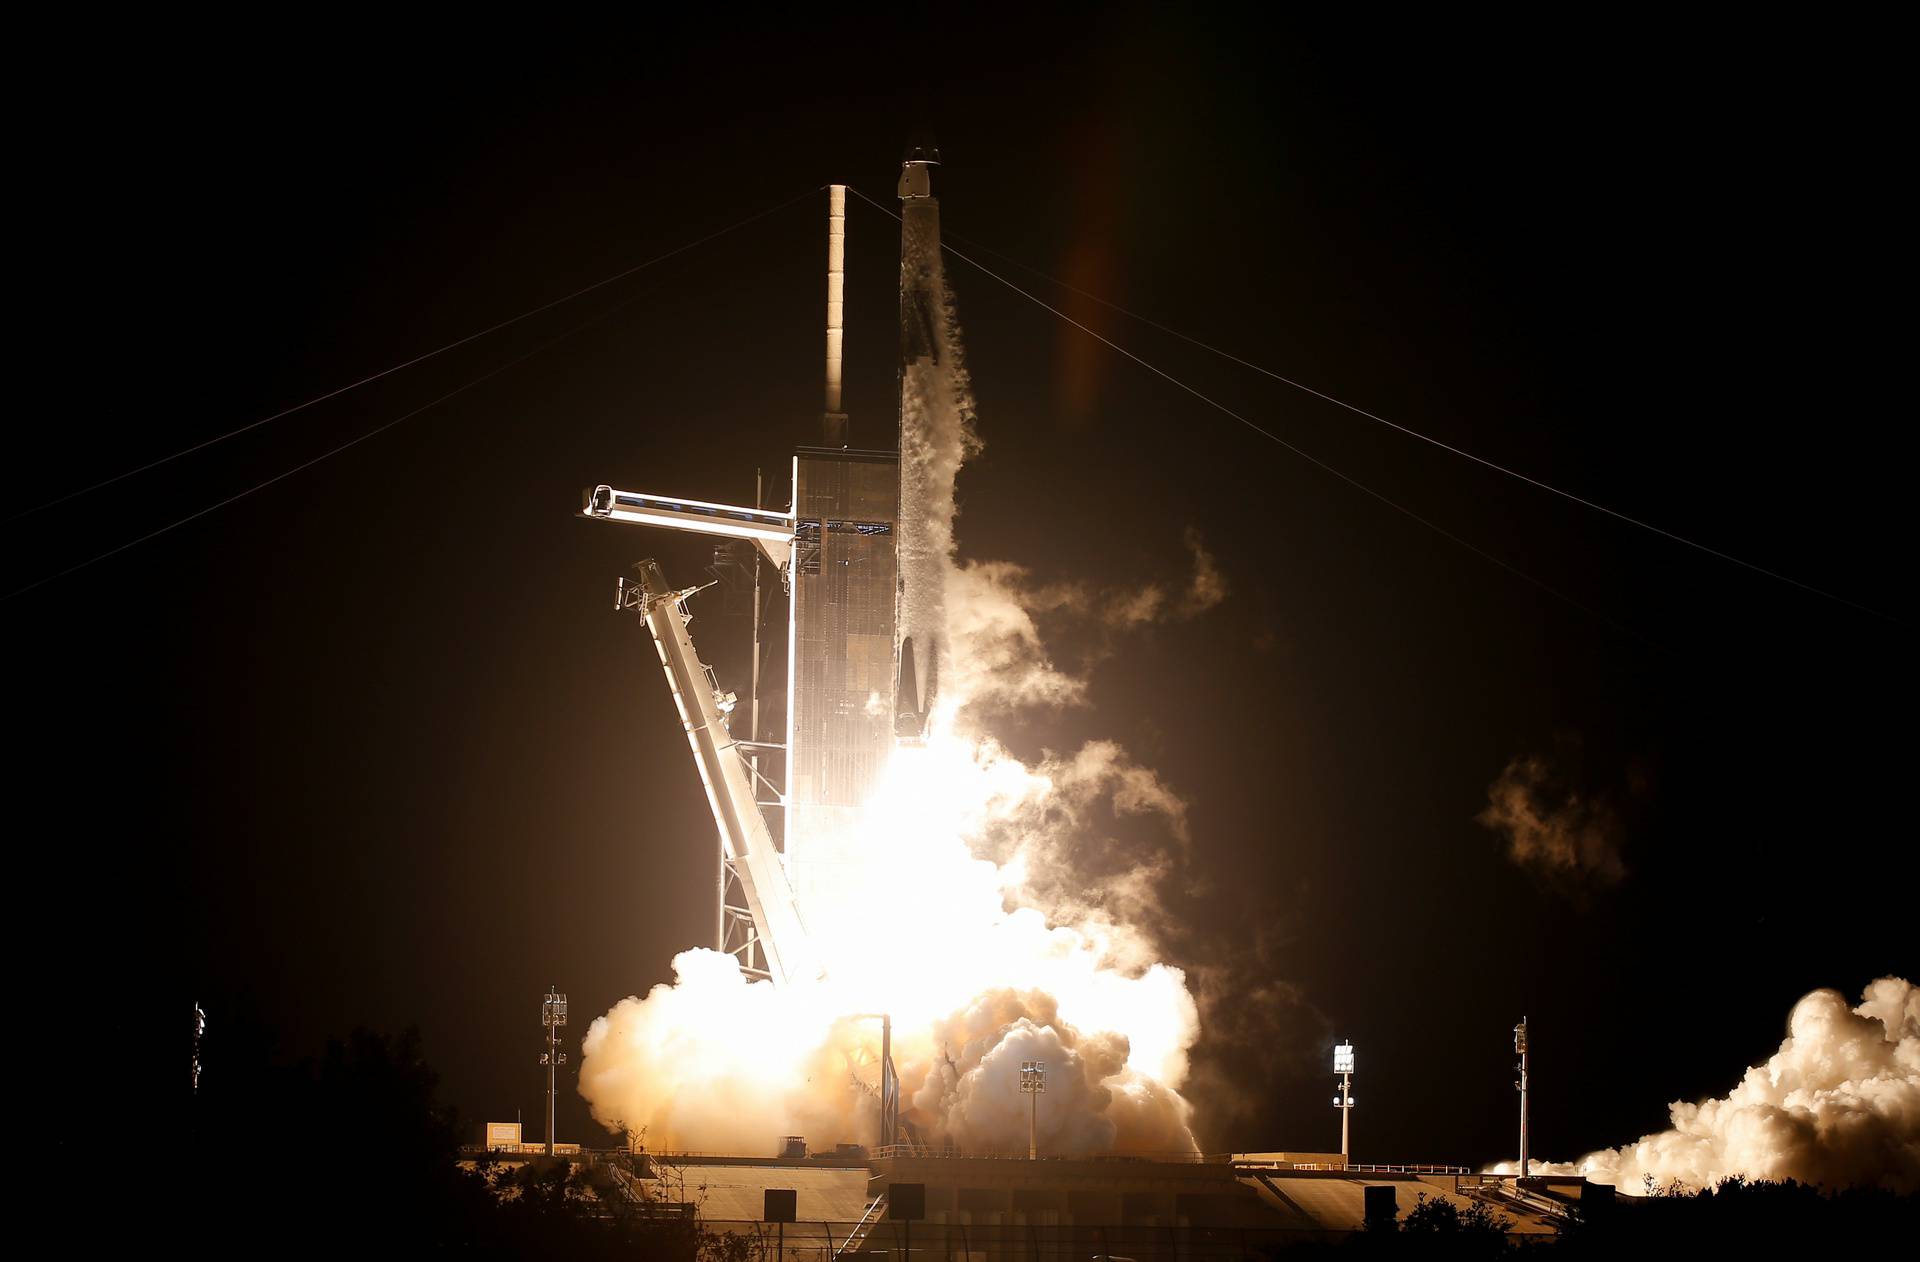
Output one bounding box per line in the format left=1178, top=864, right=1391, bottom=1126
left=1475, top=755, right=1626, bottom=886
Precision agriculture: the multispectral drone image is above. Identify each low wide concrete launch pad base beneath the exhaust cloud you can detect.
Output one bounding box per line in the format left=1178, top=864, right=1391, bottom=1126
left=472, top=1147, right=1582, bottom=1262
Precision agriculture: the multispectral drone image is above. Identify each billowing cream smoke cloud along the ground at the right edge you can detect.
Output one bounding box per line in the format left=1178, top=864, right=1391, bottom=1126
left=1498, top=978, right=1920, bottom=1193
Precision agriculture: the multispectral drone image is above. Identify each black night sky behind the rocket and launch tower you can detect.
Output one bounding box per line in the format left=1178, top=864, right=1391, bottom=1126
left=11, top=10, right=1914, bottom=1162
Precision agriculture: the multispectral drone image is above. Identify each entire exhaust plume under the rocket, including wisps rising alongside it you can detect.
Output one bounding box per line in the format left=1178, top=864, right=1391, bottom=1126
left=580, top=223, right=1225, bottom=1154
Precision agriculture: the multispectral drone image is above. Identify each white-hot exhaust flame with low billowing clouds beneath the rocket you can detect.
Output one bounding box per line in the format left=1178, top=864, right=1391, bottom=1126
left=580, top=736, right=1198, bottom=1153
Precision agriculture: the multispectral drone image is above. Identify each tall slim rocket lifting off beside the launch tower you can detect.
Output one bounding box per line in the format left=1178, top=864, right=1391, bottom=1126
left=895, top=146, right=960, bottom=741
